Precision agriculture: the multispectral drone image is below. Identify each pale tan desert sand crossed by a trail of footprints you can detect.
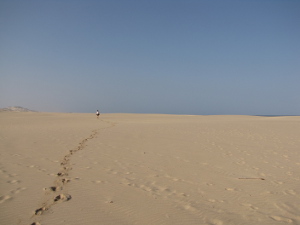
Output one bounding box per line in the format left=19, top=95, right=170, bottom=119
left=0, top=112, right=300, bottom=225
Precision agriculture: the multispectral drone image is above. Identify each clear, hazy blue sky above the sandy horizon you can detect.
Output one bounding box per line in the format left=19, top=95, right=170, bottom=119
left=0, top=0, right=300, bottom=115
